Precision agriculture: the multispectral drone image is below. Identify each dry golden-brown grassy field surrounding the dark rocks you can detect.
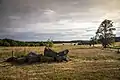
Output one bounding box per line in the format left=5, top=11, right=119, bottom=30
left=0, top=45, right=120, bottom=80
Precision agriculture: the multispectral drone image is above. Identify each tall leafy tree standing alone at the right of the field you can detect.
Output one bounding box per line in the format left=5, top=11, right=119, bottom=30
left=96, top=19, right=116, bottom=48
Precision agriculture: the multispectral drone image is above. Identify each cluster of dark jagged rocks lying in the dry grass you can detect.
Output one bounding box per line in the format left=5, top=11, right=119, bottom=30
left=6, top=47, right=69, bottom=64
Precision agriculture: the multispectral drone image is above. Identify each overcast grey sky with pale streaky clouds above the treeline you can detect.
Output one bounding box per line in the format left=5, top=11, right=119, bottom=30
left=0, top=0, right=120, bottom=41
